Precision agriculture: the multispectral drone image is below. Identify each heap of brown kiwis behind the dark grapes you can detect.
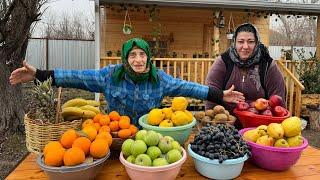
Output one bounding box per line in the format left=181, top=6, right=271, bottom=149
left=194, top=105, right=236, bottom=125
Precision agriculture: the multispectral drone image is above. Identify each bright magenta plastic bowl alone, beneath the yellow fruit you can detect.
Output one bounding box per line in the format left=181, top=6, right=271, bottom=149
left=239, top=128, right=308, bottom=171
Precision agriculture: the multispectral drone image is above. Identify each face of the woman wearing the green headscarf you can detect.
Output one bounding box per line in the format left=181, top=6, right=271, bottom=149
left=128, top=46, right=148, bottom=73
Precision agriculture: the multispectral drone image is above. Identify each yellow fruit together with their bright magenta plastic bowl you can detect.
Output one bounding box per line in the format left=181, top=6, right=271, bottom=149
left=239, top=117, right=308, bottom=171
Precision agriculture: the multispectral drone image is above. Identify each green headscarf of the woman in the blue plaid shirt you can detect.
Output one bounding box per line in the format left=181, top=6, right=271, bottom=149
left=112, top=38, right=158, bottom=83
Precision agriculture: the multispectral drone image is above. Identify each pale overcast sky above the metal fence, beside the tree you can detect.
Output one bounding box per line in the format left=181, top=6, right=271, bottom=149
left=32, top=0, right=94, bottom=37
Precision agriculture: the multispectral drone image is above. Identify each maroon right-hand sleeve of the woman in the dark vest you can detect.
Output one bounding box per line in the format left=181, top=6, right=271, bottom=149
left=265, top=61, right=286, bottom=100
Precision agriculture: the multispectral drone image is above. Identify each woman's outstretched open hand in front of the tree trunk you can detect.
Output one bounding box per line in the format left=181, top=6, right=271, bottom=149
left=9, top=60, right=37, bottom=85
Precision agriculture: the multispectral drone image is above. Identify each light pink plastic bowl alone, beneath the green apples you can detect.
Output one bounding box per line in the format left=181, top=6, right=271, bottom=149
left=119, top=148, right=187, bottom=180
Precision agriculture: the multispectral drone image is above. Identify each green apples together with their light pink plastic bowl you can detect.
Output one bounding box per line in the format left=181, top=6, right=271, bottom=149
left=119, top=130, right=187, bottom=179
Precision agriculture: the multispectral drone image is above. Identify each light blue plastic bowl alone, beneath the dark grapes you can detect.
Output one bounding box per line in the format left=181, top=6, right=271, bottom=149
left=188, top=144, right=248, bottom=179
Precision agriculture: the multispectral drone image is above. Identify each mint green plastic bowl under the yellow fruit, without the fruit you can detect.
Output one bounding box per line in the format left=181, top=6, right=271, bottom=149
left=139, top=114, right=196, bottom=145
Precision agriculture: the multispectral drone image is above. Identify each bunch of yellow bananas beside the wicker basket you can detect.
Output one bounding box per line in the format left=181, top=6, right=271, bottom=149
left=61, top=98, right=100, bottom=121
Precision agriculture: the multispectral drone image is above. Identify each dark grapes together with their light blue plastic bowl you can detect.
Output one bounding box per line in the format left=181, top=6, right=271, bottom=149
left=188, top=124, right=251, bottom=179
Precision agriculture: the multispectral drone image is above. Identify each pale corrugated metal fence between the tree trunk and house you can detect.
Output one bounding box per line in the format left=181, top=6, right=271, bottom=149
left=26, top=39, right=95, bottom=69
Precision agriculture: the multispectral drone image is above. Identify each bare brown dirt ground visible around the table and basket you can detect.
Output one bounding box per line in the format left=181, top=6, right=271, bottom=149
left=0, top=84, right=320, bottom=180
